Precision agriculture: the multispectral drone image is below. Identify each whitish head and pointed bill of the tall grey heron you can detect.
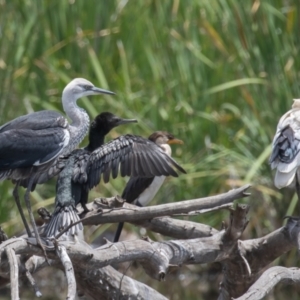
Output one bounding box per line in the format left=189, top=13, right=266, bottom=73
left=63, top=78, right=115, bottom=100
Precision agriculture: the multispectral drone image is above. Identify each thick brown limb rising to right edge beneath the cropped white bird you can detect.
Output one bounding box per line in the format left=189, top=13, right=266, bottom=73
left=219, top=218, right=300, bottom=299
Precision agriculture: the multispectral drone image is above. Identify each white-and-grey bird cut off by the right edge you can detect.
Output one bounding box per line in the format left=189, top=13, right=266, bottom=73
left=269, top=99, right=300, bottom=191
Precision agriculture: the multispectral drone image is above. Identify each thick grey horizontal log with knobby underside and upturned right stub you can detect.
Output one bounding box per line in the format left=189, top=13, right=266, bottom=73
left=0, top=205, right=248, bottom=280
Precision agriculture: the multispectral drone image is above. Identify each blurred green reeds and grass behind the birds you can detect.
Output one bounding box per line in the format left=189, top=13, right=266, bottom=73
left=0, top=0, right=300, bottom=299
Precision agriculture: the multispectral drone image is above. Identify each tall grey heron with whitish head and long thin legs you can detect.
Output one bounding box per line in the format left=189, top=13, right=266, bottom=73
left=0, top=78, right=113, bottom=244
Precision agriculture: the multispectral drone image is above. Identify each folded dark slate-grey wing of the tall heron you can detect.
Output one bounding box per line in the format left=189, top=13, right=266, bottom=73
left=0, top=110, right=68, bottom=173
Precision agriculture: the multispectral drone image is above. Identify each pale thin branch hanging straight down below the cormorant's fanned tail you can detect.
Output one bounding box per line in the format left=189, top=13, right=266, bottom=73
left=56, top=245, right=76, bottom=300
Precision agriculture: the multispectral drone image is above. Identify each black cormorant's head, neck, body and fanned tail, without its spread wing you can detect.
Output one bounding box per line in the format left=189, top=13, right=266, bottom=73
left=43, top=112, right=137, bottom=239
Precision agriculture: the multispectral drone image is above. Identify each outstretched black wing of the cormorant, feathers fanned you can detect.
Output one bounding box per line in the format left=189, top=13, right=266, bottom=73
left=87, top=134, right=185, bottom=188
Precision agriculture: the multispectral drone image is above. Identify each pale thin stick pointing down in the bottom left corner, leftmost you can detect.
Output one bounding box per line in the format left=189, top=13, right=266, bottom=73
left=5, top=247, right=19, bottom=300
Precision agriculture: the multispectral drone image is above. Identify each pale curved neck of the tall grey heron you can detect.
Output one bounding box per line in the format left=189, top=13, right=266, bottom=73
left=62, top=91, right=90, bottom=152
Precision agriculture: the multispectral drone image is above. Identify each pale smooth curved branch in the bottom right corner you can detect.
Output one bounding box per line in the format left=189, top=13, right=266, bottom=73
left=235, top=266, right=300, bottom=300
